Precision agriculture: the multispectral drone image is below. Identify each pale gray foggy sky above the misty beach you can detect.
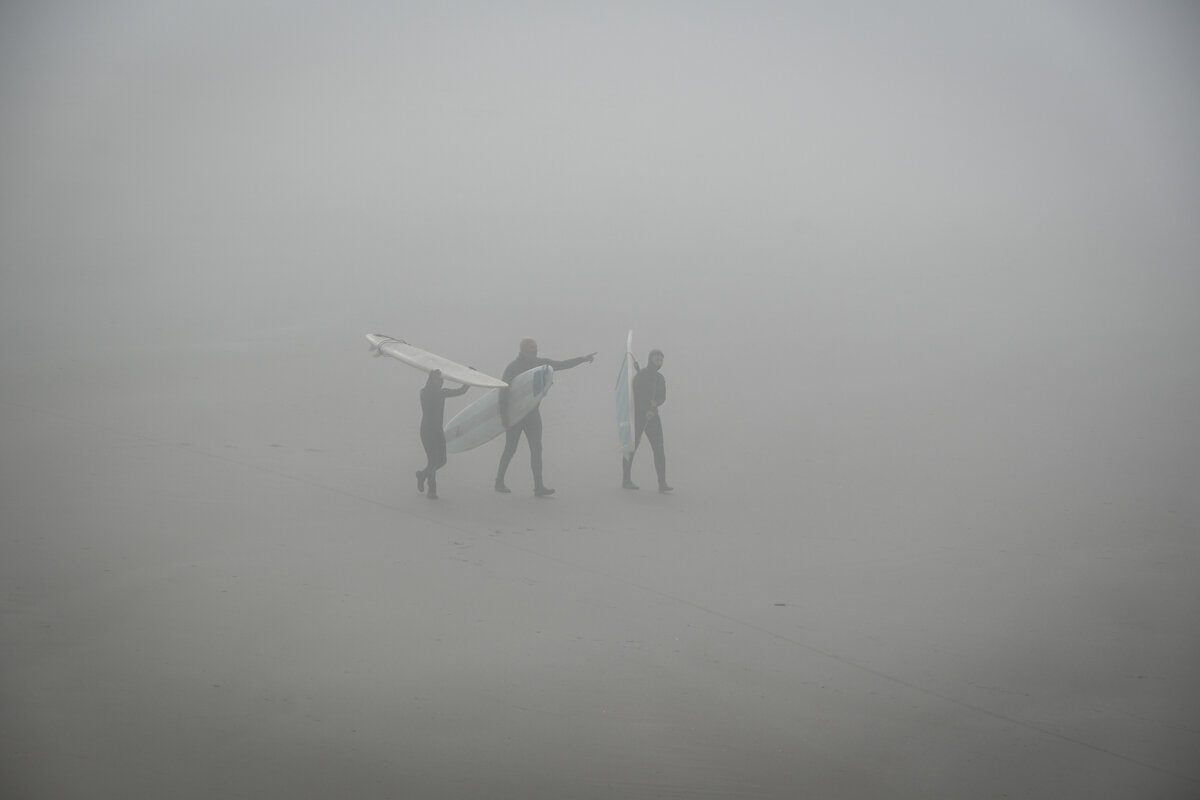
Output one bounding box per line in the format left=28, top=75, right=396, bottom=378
left=0, top=2, right=1200, bottom=357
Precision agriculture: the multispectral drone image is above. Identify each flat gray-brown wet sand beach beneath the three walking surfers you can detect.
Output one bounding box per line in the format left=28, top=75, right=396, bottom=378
left=0, top=345, right=1200, bottom=800
